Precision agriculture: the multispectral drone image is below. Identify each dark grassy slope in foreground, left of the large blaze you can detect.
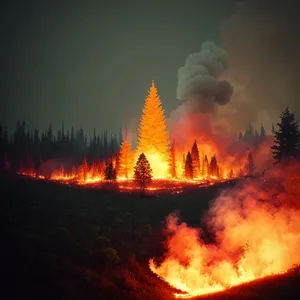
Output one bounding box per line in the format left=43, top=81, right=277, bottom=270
left=0, top=177, right=299, bottom=300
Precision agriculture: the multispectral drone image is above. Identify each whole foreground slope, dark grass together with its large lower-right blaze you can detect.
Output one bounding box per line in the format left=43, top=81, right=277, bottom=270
left=1, top=159, right=300, bottom=300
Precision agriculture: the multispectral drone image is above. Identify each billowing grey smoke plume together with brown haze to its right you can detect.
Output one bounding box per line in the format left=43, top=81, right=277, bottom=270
left=169, top=0, right=300, bottom=136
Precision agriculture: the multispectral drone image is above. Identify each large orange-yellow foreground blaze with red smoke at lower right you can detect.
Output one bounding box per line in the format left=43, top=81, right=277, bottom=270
left=149, top=164, right=300, bottom=298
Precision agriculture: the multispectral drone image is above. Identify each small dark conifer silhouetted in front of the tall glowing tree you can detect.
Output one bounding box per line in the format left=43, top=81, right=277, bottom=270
left=134, top=153, right=152, bottom=193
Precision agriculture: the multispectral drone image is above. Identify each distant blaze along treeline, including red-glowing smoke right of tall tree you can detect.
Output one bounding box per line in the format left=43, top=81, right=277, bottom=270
left=14, top=82, right=269, bottom=186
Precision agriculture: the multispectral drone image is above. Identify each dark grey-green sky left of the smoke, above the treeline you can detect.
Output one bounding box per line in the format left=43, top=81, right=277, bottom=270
left=0, top=0, right=237, bottom=132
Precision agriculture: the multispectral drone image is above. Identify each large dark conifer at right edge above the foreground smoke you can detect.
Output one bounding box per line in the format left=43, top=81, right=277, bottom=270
left=271, top=108, right=300, bottom=162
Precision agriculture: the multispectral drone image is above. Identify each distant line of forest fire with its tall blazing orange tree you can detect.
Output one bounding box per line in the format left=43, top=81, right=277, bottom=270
left=13, top=82, right=253, bottom=188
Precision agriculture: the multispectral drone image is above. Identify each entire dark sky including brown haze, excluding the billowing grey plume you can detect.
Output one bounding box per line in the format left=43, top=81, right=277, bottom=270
left=0, top=0, right=300, bottom=137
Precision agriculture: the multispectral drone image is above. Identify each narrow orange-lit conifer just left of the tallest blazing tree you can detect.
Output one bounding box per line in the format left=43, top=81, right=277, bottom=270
left=117, top=128, right=134, bottom=178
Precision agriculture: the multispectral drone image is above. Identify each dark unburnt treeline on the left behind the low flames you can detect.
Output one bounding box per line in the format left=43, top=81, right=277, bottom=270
left=0, top=121, right=122, bottom=171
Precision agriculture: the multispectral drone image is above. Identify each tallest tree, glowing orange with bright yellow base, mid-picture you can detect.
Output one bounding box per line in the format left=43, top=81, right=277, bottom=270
left=137, top=81, right=170, bottom=177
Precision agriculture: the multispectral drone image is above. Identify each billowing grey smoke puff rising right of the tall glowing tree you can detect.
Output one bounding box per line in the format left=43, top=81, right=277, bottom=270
left=177, top=41, right=233, bottom=112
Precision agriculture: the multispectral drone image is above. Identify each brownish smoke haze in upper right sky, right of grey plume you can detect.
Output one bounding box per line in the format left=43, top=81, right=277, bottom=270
left=220, top=0, right=300, bottom=129
